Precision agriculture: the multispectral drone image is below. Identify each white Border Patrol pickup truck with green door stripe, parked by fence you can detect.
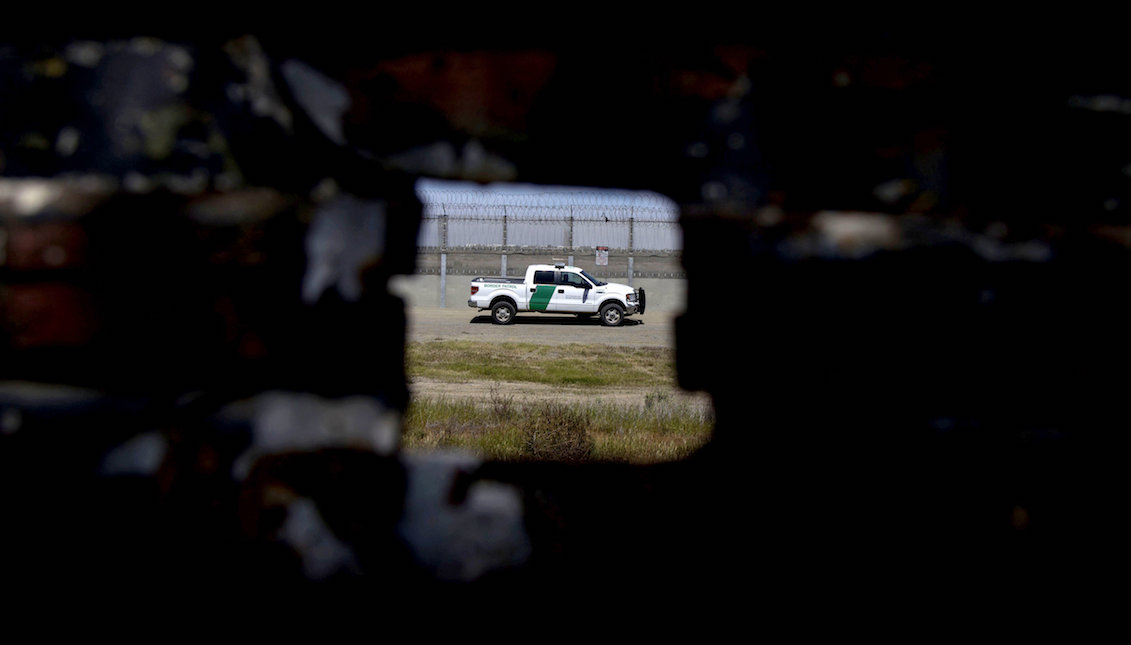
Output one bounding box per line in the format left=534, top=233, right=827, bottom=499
left=467, top=263, right=645, bottom=327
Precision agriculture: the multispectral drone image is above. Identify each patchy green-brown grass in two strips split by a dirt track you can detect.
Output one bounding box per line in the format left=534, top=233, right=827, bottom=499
left=404, top=341, right=714, bottom=463
